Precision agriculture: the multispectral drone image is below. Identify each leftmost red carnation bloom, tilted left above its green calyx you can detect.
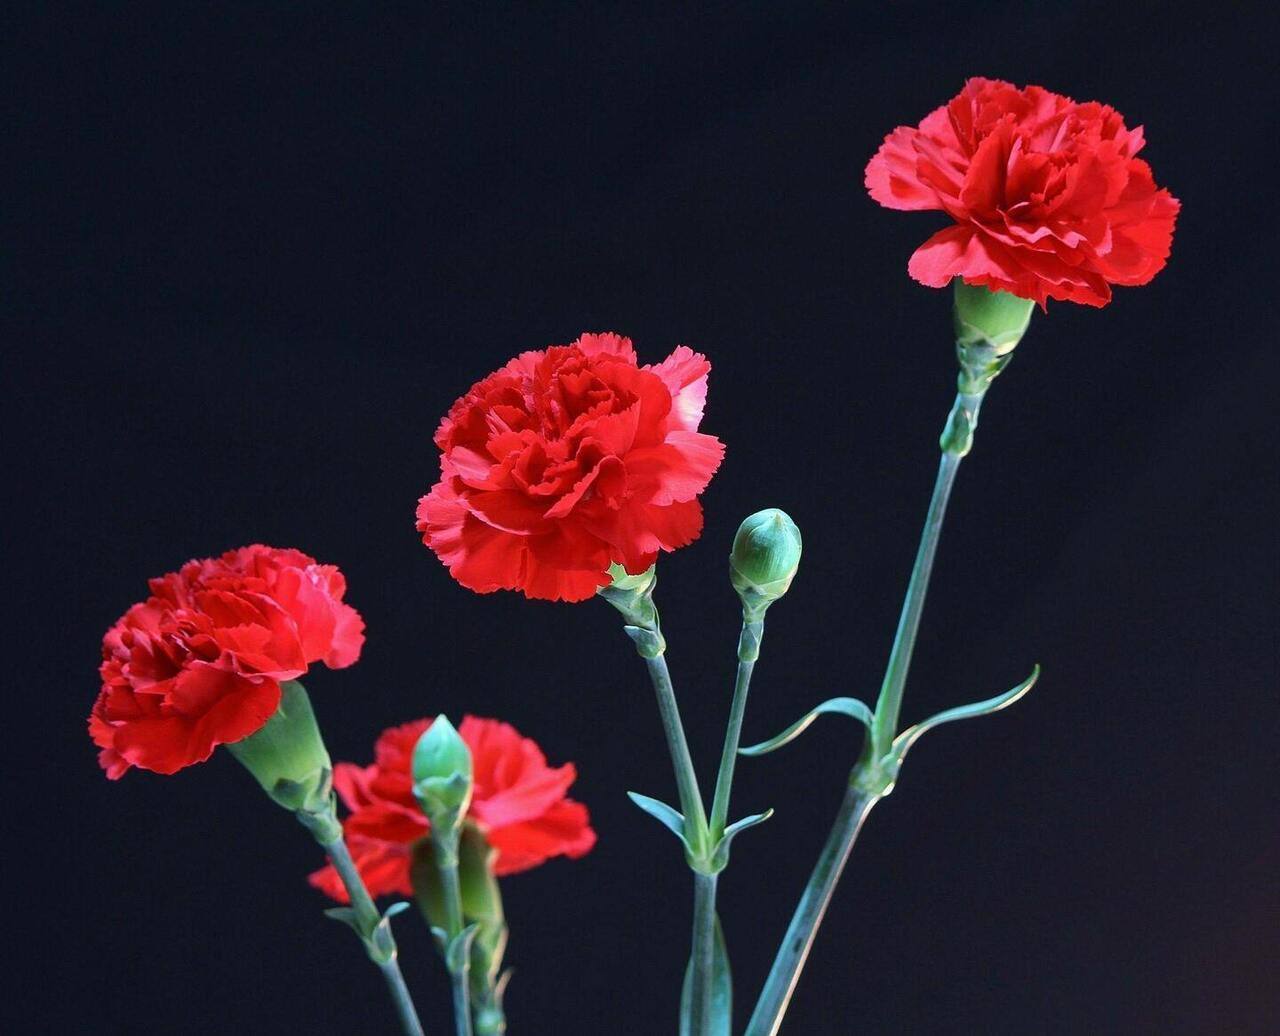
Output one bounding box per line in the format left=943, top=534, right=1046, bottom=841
left=88, top=544, right=365, bottom=780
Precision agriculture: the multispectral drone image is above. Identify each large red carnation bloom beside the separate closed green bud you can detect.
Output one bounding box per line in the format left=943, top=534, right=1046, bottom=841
left=417, top=334, right=724, bottom=601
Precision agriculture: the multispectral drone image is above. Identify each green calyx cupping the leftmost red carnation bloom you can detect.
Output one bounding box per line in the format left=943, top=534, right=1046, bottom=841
left=227, top=680, right=333, bottom=813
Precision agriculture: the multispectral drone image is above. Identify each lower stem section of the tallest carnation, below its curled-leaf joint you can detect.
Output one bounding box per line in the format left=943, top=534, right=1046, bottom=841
left=746, top=784, right=881, bottom=1036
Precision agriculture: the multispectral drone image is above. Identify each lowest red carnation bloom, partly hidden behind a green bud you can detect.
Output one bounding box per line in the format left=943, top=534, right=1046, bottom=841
left=310, top=716, right=595, bottom=903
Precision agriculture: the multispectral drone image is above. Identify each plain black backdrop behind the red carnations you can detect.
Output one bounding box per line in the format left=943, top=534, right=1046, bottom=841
left=10, top=4, right=1280, bottom=1036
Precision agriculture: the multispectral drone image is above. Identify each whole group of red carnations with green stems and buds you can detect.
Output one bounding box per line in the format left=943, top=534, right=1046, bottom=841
left=88, top=79, right=1179, bottom=1036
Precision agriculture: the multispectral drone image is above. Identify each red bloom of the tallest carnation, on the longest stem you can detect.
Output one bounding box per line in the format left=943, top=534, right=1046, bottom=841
left=867, top=79, right=1179, bottom=307
